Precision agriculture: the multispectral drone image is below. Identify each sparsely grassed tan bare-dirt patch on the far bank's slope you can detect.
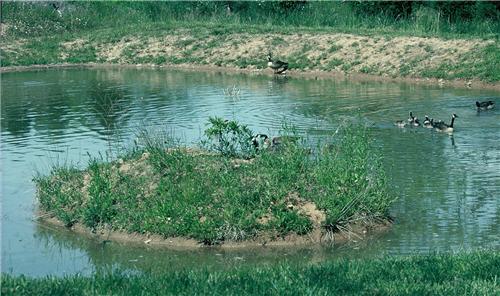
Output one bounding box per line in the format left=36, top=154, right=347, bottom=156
left=88, top=33, right=494, bottom=80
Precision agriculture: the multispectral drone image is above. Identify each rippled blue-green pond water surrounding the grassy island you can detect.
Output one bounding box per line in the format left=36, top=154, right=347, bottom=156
left=0, top=69, right=500, bottom=275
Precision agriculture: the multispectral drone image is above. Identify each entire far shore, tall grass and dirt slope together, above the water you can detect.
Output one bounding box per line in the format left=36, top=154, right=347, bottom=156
left=0, top=1, right=500, bottom=82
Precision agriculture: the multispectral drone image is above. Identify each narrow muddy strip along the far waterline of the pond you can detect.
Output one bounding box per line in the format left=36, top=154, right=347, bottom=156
left=0, top=63, right=500, bottom=91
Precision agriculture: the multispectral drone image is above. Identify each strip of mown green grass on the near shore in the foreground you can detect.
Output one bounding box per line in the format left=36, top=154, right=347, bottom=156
left=1, top=251, right=500, bottom=295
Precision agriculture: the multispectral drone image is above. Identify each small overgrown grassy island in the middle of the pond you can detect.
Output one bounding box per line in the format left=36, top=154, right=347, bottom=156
left=35, top=118, right=393, bottom=244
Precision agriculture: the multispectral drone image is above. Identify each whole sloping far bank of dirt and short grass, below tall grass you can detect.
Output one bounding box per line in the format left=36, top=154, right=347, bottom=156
left=2, top=29, right=500, bottom=90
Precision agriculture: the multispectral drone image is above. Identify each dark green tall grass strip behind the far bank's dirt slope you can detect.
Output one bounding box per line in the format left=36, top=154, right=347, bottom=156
left=2, top=1, right=500, bottom=37
